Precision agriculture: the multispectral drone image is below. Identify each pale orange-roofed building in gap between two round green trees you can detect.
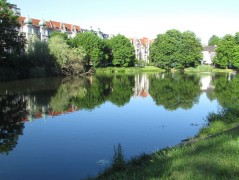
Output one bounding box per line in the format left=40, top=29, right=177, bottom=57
left=131, top=37, right=153, bottom=63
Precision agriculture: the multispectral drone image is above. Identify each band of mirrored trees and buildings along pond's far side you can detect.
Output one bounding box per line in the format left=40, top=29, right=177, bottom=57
left=0, top=74, right=239, bottom=153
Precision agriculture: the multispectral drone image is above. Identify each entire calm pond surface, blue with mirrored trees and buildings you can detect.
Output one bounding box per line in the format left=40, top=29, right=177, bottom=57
left=0, top=74, right=236, bottom=179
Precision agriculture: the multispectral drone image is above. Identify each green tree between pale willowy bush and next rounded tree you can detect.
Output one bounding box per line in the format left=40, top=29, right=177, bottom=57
left=70, top=32, right=110, bottom=67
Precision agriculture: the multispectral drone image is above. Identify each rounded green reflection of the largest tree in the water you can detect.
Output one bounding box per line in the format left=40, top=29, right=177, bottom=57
left=149, top=74, right=201, bottom=110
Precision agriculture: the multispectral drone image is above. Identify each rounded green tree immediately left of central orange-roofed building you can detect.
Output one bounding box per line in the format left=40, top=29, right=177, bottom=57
left=109, top=35, right=135, bottom=67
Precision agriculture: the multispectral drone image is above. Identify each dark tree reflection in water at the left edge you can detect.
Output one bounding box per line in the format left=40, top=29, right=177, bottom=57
left=0, top=94, right=28, bottom=154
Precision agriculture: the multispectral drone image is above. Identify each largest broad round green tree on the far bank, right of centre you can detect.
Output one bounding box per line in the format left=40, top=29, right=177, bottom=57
left=150, top=29, right=202, bottom=70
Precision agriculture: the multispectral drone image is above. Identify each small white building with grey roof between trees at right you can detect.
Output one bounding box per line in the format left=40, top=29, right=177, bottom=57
left=201, top=46, right=216, bottom=65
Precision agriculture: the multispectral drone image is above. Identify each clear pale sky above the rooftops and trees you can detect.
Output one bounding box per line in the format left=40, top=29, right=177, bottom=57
left=7, top=0, right=239, bottom=43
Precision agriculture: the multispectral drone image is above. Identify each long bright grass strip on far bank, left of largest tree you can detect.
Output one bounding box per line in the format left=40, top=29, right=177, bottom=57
left=96, top=66, right=164, bottom=74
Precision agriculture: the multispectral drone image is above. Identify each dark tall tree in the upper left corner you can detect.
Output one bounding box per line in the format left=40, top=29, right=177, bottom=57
left=0, top=0, right=25, bottom=58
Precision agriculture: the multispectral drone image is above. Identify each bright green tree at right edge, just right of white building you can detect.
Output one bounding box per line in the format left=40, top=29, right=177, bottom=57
left=214, top=34, right=238, bottom=68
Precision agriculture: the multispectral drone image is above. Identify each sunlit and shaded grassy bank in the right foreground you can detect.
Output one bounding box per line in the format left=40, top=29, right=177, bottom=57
left=93, top=109, right=239, bottom=180
